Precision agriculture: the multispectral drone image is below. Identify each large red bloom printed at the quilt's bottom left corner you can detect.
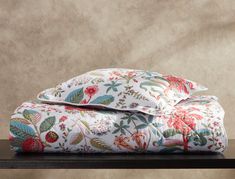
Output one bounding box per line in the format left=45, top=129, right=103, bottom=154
left=22, top=138, right=44, bottom=152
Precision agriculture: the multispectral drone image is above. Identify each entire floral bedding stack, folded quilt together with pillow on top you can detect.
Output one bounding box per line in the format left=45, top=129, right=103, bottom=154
left=10, top=68, right=227, bottom=153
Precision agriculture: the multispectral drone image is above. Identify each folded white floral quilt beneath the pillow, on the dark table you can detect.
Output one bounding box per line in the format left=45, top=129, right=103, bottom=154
left=10, top=96, right=227, bottom=153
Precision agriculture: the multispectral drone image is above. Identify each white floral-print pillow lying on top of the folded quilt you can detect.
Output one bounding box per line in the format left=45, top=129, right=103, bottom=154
left=35, top=68, right=207, bottom=115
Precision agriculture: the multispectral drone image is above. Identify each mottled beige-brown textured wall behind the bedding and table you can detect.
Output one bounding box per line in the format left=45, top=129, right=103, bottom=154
left=0, top=0, right=235, bottom=179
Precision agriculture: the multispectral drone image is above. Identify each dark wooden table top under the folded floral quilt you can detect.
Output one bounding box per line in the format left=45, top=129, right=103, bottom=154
left=0, top=140, right=235, bottom=169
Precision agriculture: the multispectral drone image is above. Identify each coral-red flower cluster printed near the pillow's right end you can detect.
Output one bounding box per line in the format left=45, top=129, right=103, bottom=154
left=166, top=76, right=193, bottom=94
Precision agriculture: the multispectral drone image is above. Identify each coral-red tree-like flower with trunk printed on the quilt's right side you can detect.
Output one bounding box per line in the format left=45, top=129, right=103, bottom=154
left=167, top=108, right=203, bottom=151
